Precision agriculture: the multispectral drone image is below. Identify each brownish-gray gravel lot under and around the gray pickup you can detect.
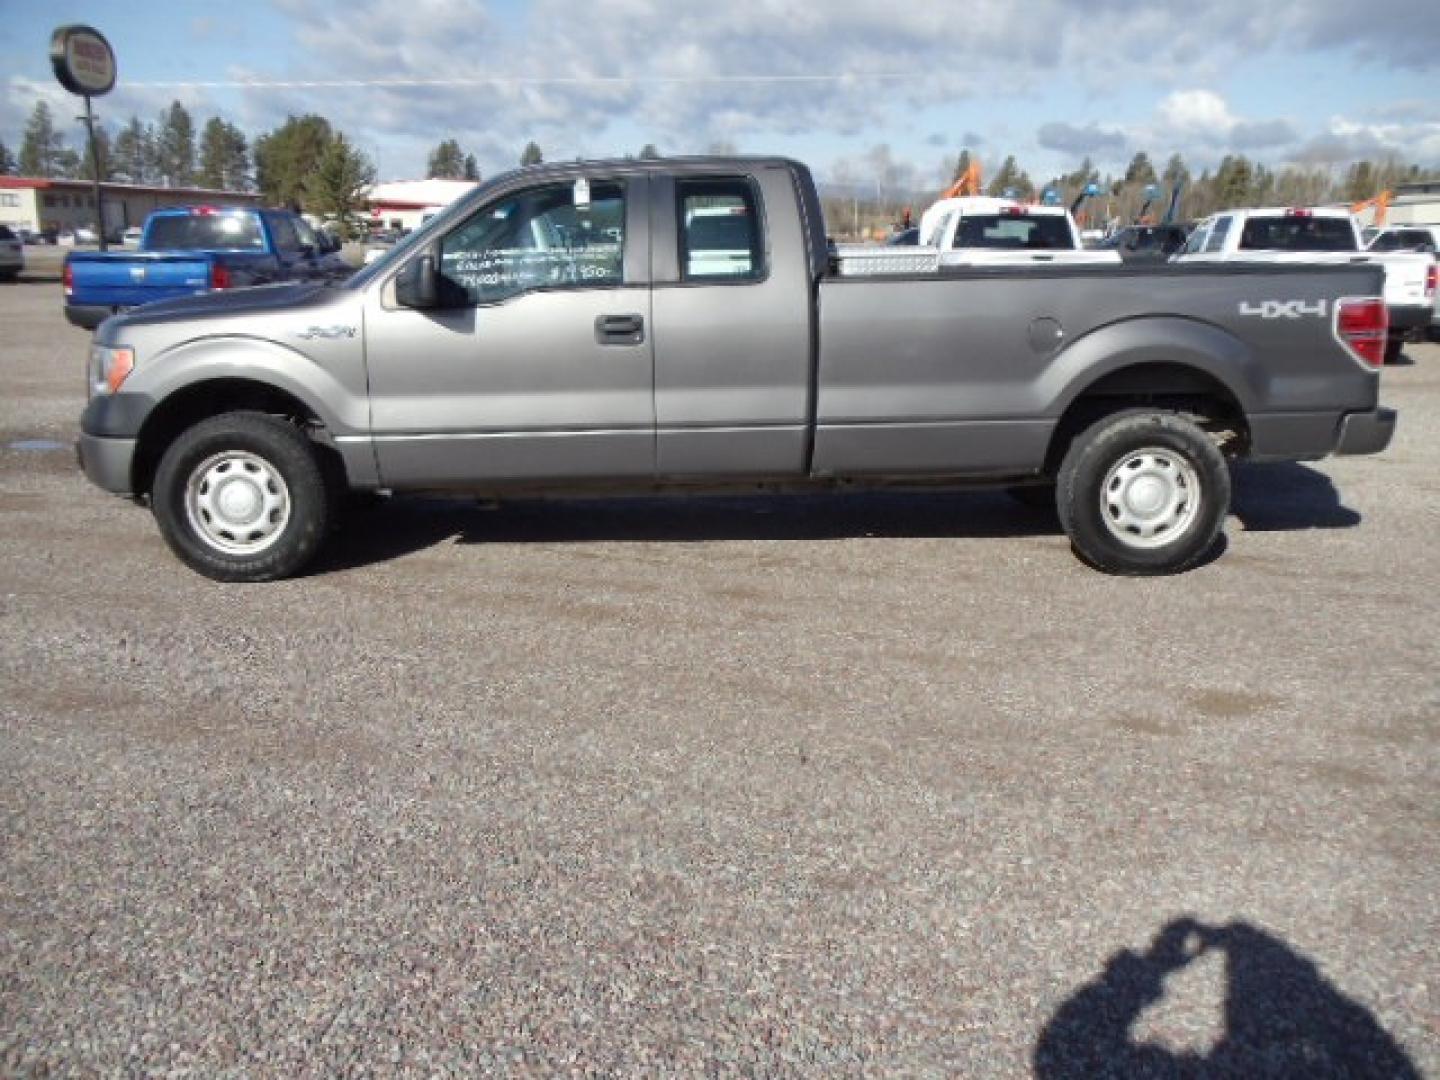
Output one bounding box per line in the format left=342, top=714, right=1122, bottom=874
left=0, top=275, right=1440, bottom=1077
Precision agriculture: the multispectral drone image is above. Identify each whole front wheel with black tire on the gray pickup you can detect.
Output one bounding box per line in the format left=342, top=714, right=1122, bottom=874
left=151, top=412, right=334, bottom=582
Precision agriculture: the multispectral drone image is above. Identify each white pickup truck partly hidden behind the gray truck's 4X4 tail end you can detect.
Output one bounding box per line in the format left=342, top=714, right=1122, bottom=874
left=1174, top=206, right=1436, bottom=360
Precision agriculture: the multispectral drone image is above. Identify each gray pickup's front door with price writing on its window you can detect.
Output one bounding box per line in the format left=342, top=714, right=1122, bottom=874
left=366, top=177, right=655, bottom=488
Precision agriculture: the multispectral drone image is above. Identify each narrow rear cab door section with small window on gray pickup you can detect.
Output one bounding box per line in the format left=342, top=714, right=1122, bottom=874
left=649, top=166, right=815, bottom=478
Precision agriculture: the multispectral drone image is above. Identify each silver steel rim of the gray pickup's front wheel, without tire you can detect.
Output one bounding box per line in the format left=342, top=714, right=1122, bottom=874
left=184, top=451, right=291, bottom=554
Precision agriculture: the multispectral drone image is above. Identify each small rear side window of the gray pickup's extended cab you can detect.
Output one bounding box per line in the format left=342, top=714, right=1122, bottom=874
left=675, top=177, right=766, bottom=281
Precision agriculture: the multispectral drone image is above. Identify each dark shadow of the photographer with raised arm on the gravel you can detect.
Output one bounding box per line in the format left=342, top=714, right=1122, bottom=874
left=1034, top=917, right=1420, bottom=1080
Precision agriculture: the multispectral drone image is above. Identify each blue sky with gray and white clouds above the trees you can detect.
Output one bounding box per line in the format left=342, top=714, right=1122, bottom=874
left=0, top=0, right=1440, bottom=186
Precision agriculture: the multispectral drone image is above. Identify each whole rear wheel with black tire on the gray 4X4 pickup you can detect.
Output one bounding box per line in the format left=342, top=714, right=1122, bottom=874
left=1056, top=409, right=1230, bottom=575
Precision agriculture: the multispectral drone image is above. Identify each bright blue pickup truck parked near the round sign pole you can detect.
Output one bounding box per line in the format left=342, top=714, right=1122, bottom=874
left=63, top=206, right=351, bottom=330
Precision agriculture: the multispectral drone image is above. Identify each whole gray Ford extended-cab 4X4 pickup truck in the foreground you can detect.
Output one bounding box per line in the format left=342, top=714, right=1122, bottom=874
left=79, top=158, right=1395, bottom=580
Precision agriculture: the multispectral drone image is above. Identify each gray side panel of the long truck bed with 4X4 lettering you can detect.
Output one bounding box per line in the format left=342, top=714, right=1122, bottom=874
left=812, top=264, right=1381, bottom=475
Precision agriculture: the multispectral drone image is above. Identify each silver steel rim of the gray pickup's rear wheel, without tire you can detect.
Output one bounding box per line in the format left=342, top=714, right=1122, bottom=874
left=1100, top=446, right=1202, bottom=549
